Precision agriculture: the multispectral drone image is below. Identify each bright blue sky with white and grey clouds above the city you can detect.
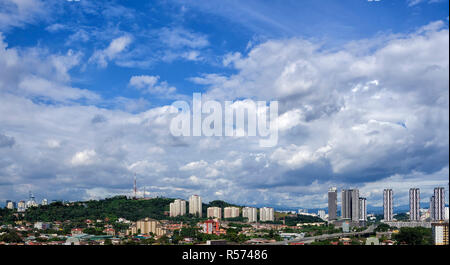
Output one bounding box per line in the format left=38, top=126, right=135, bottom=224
left=0, top=0, right=449, bottom=208
